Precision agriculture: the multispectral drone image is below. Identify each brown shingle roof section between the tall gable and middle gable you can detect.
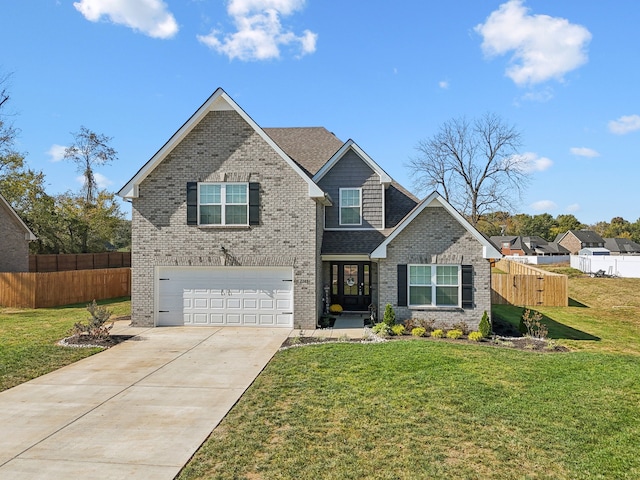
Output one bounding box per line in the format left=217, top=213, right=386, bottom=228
left=263, top=127, right=343, bottom=177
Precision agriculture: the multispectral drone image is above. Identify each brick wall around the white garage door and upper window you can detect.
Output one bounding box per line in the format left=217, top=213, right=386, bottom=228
left=132, top=111, right=321, bottom=329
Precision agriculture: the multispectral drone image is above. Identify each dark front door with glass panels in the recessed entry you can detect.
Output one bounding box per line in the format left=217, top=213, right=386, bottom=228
left=331, top=262, right=371, bottom=311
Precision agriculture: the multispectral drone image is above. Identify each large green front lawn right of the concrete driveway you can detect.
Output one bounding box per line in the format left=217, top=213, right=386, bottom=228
left=179, top=277, right=640, bottom=480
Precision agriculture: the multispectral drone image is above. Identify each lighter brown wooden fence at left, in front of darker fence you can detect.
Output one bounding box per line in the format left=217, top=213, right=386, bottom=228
left=0, top=268, right=131, bottom=308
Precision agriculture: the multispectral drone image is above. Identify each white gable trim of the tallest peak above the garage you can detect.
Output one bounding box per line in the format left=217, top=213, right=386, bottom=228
left=118, top=88, right=325, bottom=201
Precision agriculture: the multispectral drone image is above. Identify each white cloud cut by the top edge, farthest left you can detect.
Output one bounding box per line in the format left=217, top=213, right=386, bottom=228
left=73, top=0, right=178, bottom=38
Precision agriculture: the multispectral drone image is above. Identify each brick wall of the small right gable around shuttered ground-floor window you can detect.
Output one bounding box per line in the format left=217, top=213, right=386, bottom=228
left=378, top=207, right=491, bottom=329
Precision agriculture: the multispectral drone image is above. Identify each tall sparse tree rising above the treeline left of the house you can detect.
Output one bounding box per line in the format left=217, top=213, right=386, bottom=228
left=64, top=126, right=118, bottom=204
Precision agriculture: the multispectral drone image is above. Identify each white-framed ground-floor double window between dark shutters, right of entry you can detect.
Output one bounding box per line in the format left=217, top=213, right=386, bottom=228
left=408, top=265, right=460, bottom=307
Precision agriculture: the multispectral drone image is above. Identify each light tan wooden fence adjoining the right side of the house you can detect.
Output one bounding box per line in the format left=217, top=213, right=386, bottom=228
left=491, top=260, right=569, bottom=307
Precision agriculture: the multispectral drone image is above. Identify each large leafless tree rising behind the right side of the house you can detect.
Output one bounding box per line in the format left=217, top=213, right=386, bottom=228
left=408, top=113, right=529, bottom=225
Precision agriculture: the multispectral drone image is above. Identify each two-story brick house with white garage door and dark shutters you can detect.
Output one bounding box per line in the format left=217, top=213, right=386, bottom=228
left=119, top=89, right=501, bottom=329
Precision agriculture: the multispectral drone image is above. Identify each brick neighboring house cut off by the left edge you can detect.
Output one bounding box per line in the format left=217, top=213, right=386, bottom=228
left=0, top=195, right=36, bottom=272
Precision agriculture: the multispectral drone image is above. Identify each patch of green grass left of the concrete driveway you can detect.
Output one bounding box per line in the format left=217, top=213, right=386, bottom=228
left=0, top=298, right=130, bottom=391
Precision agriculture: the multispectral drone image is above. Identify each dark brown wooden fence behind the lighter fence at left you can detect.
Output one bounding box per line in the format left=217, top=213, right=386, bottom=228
left=29, top=252, right=131, bottom=272
